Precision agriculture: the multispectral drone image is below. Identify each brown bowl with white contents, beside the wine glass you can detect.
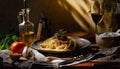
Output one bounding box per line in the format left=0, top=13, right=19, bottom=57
left=96, top=32, right=120, bottom=47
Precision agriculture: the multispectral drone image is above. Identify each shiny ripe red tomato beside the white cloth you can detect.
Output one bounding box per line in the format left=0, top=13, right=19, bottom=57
left=10, top=42, right=25, bottom=54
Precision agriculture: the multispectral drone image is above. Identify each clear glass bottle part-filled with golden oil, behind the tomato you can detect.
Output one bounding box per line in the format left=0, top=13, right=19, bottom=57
left=19, top=8, right=34, bottom=46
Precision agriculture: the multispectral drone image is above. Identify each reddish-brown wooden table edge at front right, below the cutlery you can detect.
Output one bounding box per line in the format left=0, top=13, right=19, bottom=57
left=61, top=61, right=120, bottom=69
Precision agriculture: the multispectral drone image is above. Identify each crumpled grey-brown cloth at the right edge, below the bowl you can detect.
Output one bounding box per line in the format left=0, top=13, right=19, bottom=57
left=92, top=46, right=120, bottom=62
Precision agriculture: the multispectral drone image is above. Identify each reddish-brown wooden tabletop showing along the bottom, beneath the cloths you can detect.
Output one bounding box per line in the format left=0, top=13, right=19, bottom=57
left=0, top=62, right=120, bottom=69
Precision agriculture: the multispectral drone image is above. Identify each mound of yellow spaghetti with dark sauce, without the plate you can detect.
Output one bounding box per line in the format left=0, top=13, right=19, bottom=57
left=40, top=36, right=82, bottom=52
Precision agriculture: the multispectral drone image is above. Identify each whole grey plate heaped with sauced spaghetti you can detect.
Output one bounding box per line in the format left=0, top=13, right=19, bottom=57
left=32, top=36, right=91, bottom=53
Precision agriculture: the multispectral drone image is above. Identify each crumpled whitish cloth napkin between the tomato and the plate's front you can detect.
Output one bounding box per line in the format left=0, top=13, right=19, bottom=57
left=19, top=47, right=64, bottom=69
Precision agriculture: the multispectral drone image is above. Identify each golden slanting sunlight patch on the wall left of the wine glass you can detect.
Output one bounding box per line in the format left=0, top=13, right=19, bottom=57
left=58, top=0, right=95, bottom=32
